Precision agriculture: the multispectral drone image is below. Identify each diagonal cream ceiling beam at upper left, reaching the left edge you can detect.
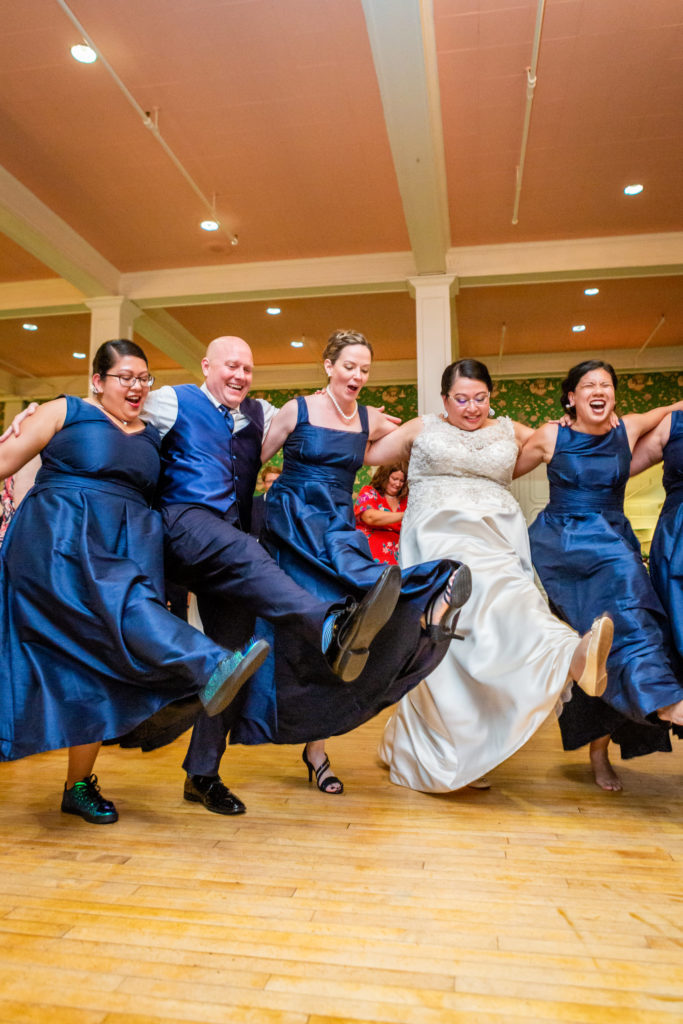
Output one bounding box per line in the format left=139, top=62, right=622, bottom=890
left=0, top=161, right=121, bottom=298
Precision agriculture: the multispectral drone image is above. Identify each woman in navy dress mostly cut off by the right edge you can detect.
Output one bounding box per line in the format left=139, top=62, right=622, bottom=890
left=631, top=411, right=683, bottom=681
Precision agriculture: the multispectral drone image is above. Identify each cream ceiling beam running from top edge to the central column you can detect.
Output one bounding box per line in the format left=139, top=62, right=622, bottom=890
left=362, top=0, right=451, bottom=274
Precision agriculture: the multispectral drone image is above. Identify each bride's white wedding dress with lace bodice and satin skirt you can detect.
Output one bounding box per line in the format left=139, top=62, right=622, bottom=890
left=379, top=415, right=579, bottom=793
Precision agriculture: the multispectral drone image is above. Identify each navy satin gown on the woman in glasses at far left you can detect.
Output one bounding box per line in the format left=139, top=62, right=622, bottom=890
left=0, top=395, right=225, bottom=760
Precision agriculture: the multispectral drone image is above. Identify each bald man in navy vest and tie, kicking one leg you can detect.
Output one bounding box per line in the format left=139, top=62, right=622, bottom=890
left=141, top=337, right=399, bottom=814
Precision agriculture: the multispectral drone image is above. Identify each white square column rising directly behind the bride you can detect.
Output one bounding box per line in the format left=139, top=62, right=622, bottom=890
left=408, top=273, right=458, bottom=416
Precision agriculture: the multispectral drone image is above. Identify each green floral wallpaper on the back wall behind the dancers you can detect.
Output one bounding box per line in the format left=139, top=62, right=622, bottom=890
left=252, top=372, right=683, bottom=494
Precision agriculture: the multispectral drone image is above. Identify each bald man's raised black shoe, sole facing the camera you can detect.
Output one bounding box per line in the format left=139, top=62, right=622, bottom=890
left=325, top=565, right=400, bottom=683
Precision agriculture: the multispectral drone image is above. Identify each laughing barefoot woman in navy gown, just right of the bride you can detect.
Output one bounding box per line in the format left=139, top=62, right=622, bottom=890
left=515, top=359, right=683, bottom=791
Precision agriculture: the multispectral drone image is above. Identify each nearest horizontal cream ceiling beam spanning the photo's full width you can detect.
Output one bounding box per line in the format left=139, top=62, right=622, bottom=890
left=0, top=231, right=683, bottom=319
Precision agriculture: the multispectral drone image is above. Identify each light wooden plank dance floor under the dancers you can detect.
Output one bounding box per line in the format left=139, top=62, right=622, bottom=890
left=0, top=716, right=683, bottom=1024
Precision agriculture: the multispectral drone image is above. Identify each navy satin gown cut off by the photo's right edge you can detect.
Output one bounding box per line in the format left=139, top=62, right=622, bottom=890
left=650, top=410, right=683, bottom=682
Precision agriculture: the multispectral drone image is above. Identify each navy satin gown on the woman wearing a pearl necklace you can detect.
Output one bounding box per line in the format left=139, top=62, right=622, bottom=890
left=230, top=397, right=459, bottom=743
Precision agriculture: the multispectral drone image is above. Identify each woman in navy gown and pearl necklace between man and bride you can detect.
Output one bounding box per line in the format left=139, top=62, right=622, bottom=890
left=230, top=331, right=470, bottom=794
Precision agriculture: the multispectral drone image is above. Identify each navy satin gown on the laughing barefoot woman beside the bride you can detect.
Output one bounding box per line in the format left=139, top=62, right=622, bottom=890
left=529, top=422, right=683, bottom=757
